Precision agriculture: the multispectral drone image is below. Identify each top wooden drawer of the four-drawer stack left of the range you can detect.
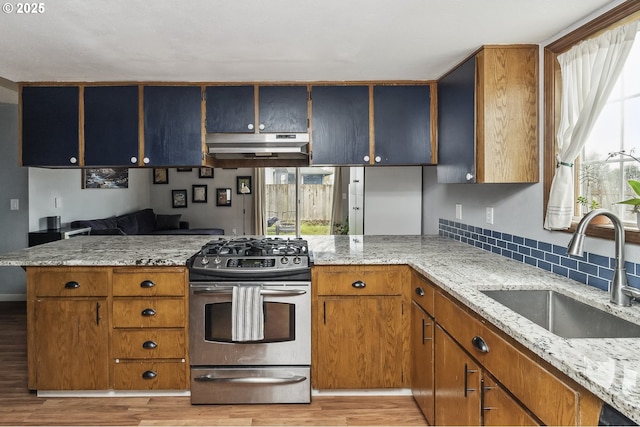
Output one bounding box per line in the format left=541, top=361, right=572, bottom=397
left=113, top=268, right=186, bottom=297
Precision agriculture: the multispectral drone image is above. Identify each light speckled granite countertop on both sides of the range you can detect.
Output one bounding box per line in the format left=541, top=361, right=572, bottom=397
left=0, top=236, right=640, bottom=423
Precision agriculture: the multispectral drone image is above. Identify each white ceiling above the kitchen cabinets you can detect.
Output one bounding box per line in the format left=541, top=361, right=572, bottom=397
left=0, top=0, right=622, bottom=82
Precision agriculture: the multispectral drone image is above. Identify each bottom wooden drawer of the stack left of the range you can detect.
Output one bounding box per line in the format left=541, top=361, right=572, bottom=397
left=113, top=361, right=189, bottom=390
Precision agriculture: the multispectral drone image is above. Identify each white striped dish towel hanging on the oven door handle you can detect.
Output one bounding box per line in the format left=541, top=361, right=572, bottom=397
left=231, top=286, right=264, bottom=341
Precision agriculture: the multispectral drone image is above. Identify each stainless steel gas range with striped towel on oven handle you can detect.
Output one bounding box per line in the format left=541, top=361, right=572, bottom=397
left=188, top=238, right=313, bottom=404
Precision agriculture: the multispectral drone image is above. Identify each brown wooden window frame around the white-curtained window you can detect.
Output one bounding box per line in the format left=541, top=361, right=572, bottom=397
left=543, top=0, right=640, bottom=244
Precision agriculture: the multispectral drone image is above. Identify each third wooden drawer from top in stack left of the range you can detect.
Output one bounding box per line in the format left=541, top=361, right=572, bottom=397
left=112, top=329, right=186, bottom=359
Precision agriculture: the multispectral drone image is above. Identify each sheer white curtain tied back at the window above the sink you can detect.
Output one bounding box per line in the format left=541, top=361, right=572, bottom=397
left=544, top=21, right=638, bottom=230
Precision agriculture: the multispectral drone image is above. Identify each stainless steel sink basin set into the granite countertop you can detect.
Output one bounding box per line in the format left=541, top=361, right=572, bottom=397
left=482, top=290, right=640, bottom=338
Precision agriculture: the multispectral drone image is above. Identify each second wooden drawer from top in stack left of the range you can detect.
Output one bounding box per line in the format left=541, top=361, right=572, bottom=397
left=113, top=298, right=186, bottom=328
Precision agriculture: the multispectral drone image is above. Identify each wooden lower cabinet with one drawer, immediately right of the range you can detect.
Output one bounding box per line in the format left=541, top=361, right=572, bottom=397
left=312, top=266, right=410, bottom=389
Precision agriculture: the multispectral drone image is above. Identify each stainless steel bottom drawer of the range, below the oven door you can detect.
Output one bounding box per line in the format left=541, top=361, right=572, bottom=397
left=191, top=366, right=311, bottom=404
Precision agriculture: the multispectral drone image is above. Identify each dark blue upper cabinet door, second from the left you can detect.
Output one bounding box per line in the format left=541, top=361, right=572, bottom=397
left=84, top=86, right=139, bottom=166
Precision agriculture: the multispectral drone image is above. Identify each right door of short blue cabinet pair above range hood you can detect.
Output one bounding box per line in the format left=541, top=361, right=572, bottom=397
left=258, top=86, right=309, bottom=133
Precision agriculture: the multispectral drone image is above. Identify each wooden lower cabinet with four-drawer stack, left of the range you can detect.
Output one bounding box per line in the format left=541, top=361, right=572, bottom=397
left=27, top=267, right=189, bottom=390
